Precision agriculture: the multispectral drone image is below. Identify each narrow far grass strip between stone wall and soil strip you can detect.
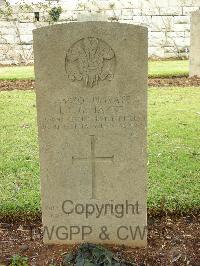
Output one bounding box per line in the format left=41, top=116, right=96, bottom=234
left=0, top=60, right=189, bottom=80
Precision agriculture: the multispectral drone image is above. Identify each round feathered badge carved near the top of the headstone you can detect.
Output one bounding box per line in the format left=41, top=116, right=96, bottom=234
left=65, top=37, right=115, bottom=88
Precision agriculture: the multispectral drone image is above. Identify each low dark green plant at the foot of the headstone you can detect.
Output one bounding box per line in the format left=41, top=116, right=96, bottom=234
left=63, top=243, right=136, bottom=266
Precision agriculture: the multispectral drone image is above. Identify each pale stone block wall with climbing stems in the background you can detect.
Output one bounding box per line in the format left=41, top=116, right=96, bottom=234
left=0, top=0, right=200, bottom=64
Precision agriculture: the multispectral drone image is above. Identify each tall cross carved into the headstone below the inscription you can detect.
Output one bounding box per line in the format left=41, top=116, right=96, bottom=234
left=72, top=135, right=114, bottom=199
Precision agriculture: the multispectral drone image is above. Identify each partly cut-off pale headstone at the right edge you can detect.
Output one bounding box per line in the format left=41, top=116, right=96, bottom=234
left=190, top=11, right=200, bottom=77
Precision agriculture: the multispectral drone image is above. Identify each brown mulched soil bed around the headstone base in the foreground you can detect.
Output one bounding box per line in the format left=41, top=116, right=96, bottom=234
left=0, top=215, right=200, bottom=266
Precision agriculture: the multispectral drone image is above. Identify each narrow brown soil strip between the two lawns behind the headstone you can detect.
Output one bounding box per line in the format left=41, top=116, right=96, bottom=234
left=0, top=77, right=200, bottom=91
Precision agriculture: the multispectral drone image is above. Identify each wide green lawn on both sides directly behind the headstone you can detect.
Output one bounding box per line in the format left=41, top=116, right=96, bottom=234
left=0, top=88, right=200, bottom=214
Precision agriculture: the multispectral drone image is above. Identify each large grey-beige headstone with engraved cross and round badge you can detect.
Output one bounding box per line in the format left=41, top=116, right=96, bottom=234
left=34, top=22, right=147, bottom=246
